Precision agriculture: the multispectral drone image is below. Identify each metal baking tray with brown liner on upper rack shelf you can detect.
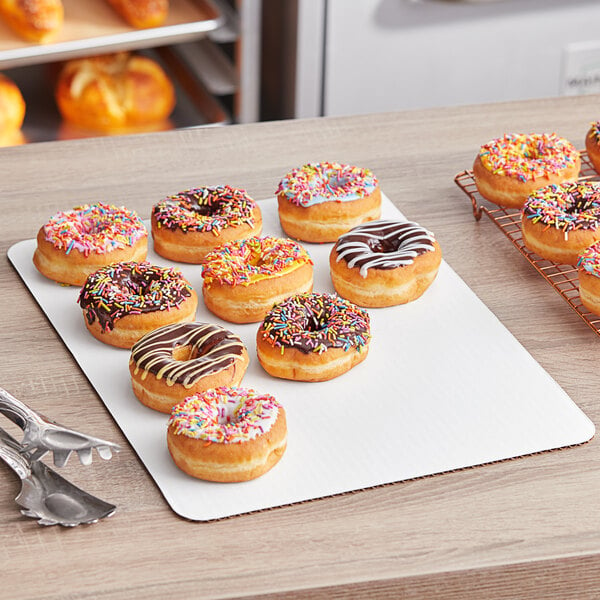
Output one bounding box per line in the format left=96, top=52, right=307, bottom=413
left=0, top=0, right=222, bottom=69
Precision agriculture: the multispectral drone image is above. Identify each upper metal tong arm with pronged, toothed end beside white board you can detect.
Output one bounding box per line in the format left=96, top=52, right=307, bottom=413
left=0, top=388, right=121, bottom=467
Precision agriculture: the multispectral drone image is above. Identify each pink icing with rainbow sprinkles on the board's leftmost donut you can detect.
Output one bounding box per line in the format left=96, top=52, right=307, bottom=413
left=44, top=203, right=148, bottom=256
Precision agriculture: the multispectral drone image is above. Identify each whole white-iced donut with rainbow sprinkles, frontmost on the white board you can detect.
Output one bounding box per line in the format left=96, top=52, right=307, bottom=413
left=167, top=387, right=287, bottom=482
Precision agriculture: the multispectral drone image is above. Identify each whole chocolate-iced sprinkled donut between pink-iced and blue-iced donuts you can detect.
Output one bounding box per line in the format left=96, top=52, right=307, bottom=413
left=152, top=185, right=262, bottom=263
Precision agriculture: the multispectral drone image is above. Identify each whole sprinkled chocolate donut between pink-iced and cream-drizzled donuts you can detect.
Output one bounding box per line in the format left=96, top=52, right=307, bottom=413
left=78, top=262, right=198, bottom=348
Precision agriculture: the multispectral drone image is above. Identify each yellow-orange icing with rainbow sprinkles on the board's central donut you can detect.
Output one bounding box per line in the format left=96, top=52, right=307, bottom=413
left=202, top=237, right=313, bottom=287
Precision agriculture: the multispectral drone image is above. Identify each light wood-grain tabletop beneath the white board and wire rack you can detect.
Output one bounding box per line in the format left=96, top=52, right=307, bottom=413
left=0, top=97, right=600, bottom=600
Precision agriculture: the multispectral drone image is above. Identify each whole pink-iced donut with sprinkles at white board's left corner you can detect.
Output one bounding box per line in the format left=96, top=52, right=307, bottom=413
left=33, top=203, right=148, bottom=285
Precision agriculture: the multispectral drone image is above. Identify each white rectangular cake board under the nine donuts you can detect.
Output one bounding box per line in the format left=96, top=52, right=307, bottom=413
left=8, top=198, right=594, bottom=520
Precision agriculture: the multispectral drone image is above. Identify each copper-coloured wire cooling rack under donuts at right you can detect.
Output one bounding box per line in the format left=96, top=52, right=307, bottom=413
left=454, top=152, right=600, bottom=335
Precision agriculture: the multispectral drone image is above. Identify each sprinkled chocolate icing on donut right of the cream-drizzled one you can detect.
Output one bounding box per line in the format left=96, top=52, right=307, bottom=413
left=262, top=293, right=371, bottom=354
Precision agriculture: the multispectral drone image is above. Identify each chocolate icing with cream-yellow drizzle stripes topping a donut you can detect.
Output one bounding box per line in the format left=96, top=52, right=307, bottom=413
left=131, top=323, right=245, bottom=388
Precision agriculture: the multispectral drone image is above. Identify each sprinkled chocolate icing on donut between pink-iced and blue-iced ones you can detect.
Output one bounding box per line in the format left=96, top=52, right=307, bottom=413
left=152, top=185, right=257, bottom=236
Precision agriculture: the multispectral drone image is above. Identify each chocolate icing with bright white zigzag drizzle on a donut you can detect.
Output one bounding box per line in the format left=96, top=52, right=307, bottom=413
left=335, top=220, right=435, bottom=277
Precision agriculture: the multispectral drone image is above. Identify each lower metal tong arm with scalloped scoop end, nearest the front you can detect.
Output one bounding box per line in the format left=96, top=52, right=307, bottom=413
left=0, top=428, right=116, bottom=527
